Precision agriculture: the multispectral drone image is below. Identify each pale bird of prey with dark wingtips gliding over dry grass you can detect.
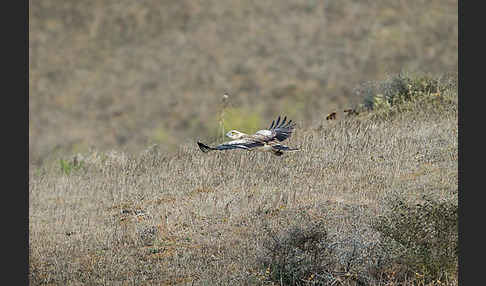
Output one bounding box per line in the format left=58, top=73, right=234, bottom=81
left=197, top=116, right=299, bottom=156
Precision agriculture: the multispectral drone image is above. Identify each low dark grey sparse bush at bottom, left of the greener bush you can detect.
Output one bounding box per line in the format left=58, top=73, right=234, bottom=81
left=261, top=223, right=383, bottom=285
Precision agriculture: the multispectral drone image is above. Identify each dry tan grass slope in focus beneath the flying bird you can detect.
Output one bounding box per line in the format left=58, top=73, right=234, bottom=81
left=29, top=75, right=458, bottom=285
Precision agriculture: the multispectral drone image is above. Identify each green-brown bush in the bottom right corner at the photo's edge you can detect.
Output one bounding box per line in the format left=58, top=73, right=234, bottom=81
left=374, top=194, right=458, bottom=283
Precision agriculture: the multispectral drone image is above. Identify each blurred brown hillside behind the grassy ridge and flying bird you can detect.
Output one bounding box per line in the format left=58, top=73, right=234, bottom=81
left=29, top=0, right=458, bottom=165
